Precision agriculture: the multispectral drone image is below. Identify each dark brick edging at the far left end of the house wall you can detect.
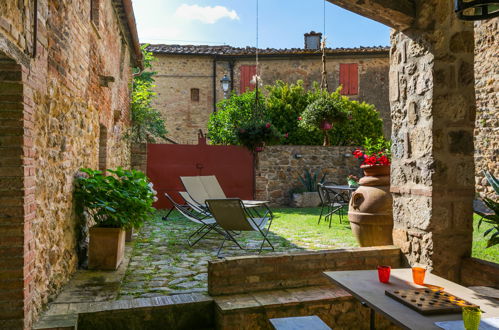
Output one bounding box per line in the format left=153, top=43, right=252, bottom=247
left=0, top=53, right=28, bottom=329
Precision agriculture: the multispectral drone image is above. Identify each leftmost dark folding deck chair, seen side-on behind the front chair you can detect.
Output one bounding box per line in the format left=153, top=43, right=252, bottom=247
left=165, top=193, right=225, bottom=247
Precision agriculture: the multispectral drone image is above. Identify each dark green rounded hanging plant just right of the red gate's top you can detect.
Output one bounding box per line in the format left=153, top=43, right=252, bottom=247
left=236, top=119, right=282, bottom=152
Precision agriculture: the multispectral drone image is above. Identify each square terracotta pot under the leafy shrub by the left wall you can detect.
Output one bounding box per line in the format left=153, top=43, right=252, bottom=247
left=88, top=227, right=125, bottom=270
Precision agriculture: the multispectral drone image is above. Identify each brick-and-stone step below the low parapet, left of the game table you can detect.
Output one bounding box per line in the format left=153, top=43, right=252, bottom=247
left=214, top=286, right=398, bottom=330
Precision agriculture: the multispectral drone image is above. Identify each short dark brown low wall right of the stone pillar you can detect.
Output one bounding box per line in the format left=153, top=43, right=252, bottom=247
left=461, top=258, right=499, bottom=289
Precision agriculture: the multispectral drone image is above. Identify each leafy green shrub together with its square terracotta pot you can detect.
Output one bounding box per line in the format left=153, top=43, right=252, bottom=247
left=75, top=168, right=156, bottom=270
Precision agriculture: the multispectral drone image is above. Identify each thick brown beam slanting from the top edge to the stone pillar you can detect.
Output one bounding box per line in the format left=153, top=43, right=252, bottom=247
left=328, top=0, right=416, bottom=30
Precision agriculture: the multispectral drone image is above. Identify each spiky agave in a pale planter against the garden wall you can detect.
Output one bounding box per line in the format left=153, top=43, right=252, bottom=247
left=291, top=169, right=327, bottom=207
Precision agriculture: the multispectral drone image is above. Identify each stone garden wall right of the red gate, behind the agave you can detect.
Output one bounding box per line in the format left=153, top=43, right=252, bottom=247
left=255, top=146, right=361, bottom=205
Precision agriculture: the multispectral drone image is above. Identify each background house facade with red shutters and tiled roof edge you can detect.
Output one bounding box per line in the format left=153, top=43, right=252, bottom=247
left=148, top=39, right=391, bottom=144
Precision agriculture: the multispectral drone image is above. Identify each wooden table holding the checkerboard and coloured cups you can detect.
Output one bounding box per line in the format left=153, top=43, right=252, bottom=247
left=324, top=268, right=499, bottom=330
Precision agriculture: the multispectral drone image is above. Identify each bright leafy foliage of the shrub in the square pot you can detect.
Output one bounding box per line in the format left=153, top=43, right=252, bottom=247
left=75, top=167, right=156, bottom=229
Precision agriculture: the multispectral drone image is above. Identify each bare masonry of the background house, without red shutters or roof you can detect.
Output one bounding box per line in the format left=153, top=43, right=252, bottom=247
left=153, top=53, right=391, bottom=144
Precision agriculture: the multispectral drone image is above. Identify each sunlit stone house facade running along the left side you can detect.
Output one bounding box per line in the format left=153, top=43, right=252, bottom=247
left=0, top=0, right=141, bottom=329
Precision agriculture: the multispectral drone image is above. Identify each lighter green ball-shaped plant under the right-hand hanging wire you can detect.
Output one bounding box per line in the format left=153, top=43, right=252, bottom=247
left=299, top=92, right=348, bottom=146
